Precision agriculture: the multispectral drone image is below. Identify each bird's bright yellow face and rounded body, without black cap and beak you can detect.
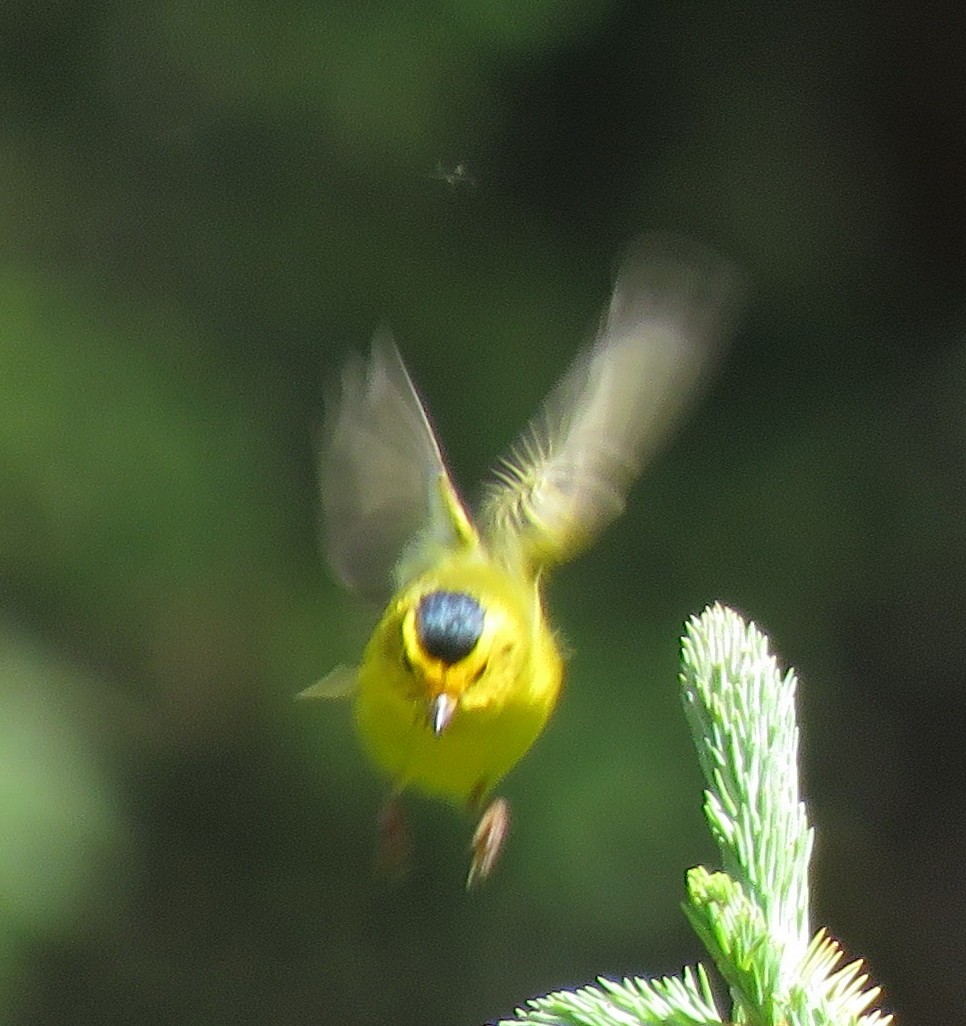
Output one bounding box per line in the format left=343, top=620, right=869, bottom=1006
left=356, top=548, right=563, bottom=801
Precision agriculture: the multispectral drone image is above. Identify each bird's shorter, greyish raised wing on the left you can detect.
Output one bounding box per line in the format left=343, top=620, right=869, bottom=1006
left=320, top=330, right=476, bottom=602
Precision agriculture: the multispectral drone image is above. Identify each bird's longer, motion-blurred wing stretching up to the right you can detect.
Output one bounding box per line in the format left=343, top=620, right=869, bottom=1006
left=482, top=236, right=737, bottom=568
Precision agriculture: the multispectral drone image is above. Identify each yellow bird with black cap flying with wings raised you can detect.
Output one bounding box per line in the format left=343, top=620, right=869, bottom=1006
left=303, top=237, right=734, bottom=886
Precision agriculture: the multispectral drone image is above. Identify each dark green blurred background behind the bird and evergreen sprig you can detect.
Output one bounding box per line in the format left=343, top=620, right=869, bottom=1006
left=0, top=0, right=966, bottom=1026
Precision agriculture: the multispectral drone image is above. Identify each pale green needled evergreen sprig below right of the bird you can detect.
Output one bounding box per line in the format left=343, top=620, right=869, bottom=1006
left=498, top=604, right=892, bottom=1026
